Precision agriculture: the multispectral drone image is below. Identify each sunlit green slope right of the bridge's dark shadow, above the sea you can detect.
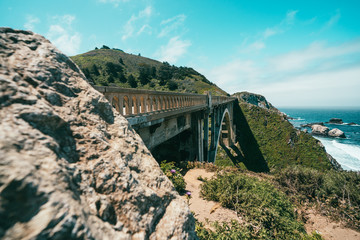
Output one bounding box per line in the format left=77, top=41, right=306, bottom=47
left=233, top=92, right=341, bottom=170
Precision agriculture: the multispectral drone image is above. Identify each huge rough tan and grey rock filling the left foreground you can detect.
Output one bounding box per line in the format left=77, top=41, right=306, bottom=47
left=0, top=28, right=196, bottom=239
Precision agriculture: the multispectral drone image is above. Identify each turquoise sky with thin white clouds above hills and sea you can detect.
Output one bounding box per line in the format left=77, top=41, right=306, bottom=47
left=0, top=0, right=360, bottom=108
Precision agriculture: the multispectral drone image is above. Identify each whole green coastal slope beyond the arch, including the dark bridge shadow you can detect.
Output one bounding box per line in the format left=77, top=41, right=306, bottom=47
left=216, top=93, right=336, bottom=172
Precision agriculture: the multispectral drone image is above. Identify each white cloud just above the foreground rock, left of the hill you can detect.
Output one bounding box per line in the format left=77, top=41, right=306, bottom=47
left=46, top=15, right=81, bottom=55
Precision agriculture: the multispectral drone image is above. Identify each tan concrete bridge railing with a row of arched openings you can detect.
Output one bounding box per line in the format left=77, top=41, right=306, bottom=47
left=94, top=86, right=235, bottom=117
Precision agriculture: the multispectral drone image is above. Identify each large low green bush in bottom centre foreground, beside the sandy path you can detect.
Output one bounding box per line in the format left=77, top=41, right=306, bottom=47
left=200, top=173, right=306, bottom=239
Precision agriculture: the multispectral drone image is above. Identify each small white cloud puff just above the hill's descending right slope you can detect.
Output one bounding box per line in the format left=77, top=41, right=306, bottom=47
left=155, top=36, right=191, bottom=64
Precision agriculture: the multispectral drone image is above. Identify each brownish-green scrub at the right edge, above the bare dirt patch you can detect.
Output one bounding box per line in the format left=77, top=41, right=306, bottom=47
left=275, top=166, right=360, bottom=230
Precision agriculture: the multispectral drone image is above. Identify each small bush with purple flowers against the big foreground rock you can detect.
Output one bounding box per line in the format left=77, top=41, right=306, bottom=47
left=160, top=161, right=186, bottom=194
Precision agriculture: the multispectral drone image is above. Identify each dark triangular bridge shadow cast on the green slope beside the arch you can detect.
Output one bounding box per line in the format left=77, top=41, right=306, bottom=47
left=226, top=101, right=269, bottom=172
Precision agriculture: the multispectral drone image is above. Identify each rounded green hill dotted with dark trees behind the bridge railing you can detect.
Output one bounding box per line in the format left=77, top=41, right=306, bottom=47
left=71, top=46, right=227, bottom=95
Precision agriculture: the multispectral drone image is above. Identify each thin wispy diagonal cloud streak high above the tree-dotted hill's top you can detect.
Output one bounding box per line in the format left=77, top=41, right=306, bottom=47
left=121, top=6, right=153, bottom=41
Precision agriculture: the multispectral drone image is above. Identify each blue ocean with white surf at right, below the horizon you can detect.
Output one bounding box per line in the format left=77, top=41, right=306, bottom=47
left=279, top=108, right=360, bottom=171
